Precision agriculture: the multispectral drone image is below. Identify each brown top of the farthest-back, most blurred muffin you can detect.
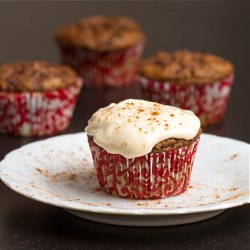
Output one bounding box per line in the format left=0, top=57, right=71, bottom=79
left=56, top=16, right=144, bottom=51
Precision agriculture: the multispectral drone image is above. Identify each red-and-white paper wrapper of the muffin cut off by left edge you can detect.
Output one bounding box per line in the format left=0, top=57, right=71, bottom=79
left=0, top=79, right=82, bottom=136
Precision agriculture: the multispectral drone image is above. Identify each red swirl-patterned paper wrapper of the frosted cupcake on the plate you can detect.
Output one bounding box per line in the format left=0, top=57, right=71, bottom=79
left=89, top=139, right=199, bottom=199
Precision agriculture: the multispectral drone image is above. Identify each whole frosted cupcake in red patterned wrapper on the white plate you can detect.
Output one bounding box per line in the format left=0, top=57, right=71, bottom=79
left=85, top=99, right=201, bottom=199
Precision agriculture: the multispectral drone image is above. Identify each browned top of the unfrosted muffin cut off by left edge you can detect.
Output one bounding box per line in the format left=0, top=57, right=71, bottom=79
left=0, top=61, right=77, bottom=92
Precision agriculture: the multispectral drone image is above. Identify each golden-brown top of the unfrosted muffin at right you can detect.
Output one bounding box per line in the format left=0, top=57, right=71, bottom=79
left=140, top=50, right=234, bottom=85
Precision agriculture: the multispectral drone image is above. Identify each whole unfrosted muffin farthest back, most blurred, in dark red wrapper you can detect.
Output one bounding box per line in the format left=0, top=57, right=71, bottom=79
left=56, top=16, right=145, bottom=88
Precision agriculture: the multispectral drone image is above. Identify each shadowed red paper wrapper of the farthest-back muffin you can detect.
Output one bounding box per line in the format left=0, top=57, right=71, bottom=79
left=58, top=41, right=144, bottom=88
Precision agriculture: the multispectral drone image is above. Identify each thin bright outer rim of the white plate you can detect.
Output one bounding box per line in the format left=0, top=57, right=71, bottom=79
left=0, top=132, right=250, bottom=216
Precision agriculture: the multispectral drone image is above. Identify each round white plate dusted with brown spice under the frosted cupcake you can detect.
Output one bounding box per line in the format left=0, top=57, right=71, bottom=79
left=0, top=133, right=250, bottom=226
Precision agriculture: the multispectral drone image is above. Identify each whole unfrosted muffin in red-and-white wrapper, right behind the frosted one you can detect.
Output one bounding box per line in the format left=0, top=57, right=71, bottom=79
left=138, top=50, right=234, bottom=126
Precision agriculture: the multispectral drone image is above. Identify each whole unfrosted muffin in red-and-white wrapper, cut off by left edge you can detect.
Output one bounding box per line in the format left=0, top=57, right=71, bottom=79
left=0, top=61, right=82, bottom=136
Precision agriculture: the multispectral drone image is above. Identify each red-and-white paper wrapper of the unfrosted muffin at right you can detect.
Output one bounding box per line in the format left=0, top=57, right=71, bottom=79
left=138, top=76, right=234, bottom=126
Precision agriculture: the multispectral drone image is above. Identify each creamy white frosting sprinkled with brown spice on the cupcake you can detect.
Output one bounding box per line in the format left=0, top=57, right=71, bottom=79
left=85, top=99, right=200, bottom=159
